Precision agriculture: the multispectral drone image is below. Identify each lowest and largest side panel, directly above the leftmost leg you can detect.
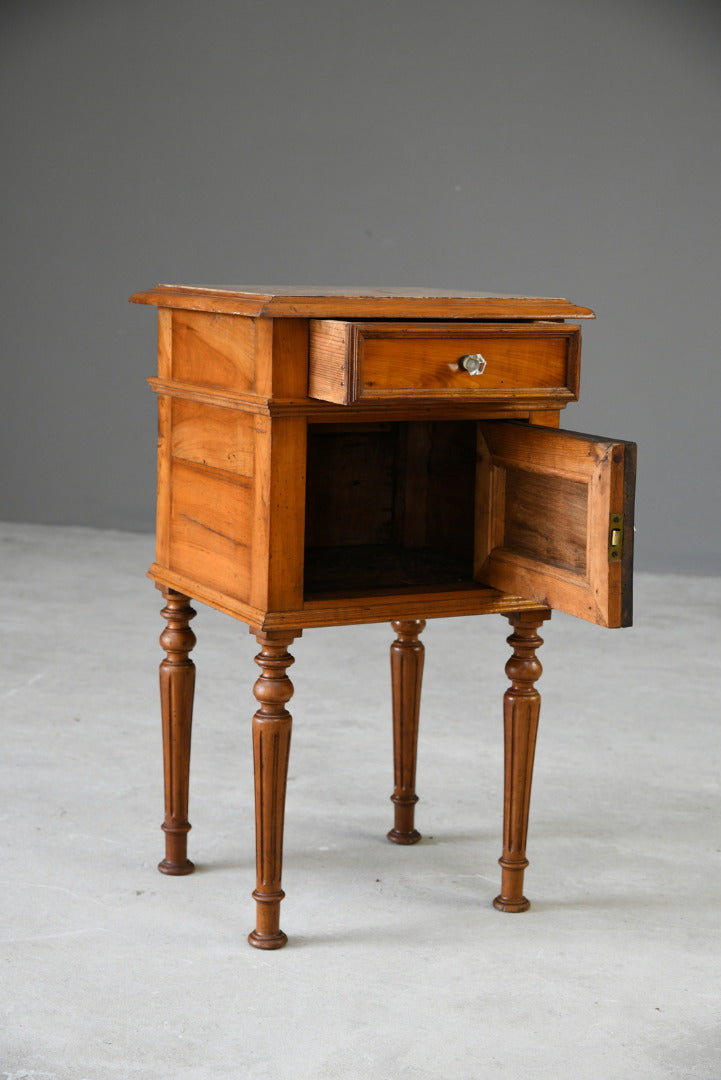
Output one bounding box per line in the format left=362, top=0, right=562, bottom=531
left=168, top=460, right=253, bottom=602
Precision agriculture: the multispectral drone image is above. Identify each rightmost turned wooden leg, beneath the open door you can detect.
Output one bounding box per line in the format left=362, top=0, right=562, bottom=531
left=493, top=611, right=550, bottom=912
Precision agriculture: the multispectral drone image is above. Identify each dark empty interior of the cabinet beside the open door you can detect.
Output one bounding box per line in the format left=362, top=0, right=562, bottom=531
left=304, top=420, right=477, bottom=598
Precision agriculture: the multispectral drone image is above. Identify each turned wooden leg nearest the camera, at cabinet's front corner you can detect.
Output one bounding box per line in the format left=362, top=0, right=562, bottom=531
left=248, top=631, right=300, bottom=948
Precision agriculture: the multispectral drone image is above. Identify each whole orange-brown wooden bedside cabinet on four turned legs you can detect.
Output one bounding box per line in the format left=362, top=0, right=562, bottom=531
left=132, top=285, right=635, bottom=948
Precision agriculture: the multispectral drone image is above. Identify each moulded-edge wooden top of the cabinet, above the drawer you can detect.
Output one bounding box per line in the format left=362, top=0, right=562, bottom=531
left=131, top=284, right=594, bottom=319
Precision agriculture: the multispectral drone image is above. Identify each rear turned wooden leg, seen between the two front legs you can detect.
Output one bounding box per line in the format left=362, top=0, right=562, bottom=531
left=387, top=619, right=425, bottom=843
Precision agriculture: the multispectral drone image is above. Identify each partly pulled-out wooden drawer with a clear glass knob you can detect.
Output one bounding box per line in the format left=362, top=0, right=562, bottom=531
left=309, top=319, right=581, bottom=408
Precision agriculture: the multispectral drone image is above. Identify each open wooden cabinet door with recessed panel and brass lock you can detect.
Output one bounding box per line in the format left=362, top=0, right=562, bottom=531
left=475, top=420, right=636, bottom=626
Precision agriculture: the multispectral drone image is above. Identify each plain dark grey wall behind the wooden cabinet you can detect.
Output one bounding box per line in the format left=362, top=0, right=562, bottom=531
left=0, top=0, right=721, bottom=572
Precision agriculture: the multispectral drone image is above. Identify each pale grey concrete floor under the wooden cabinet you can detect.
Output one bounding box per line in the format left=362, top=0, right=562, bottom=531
left=0, top=525, right=721, bottom=1080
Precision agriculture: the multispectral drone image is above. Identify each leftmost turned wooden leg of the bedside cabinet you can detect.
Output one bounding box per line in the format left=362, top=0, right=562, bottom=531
left=158, top=589, right=195, bottom=874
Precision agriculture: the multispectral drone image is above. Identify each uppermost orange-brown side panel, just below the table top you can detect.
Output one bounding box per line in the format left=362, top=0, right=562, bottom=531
left=172, top=311, right=256, bottom=391
